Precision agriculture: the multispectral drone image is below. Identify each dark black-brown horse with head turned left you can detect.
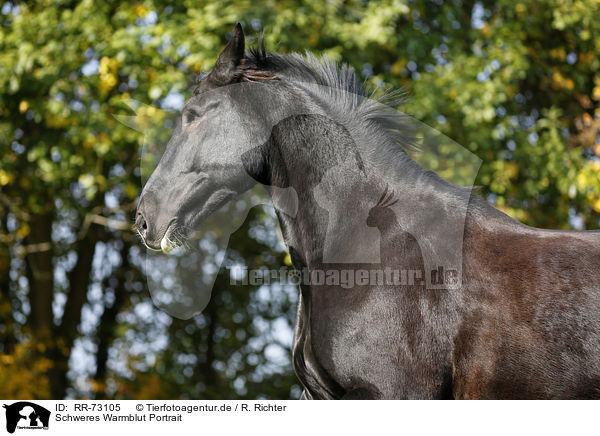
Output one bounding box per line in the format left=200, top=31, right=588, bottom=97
left=136, top=24, right=600, bottom=399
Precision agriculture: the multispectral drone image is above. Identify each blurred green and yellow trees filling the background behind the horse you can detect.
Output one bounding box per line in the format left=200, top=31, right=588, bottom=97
left=0, top=0, right=600, bottom=398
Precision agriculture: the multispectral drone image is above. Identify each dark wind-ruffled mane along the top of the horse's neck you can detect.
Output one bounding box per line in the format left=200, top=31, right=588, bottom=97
left=194, top=36, right=470, bottom=192
